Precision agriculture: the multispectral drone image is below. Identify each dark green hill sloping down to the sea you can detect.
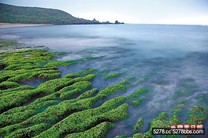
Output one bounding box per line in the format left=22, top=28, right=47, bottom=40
left=0, top=3, right=100, bottom=24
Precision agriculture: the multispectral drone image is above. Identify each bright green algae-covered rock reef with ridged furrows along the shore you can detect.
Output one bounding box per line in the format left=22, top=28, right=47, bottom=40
left=0, top=41, right=208, bottom=138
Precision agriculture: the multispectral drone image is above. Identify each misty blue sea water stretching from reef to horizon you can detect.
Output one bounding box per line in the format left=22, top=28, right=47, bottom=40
left=0, top=24, right=208, bottom=137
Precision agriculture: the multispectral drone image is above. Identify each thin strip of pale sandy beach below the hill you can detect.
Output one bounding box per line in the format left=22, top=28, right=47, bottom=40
left=0, top=23, right=49, bottom=29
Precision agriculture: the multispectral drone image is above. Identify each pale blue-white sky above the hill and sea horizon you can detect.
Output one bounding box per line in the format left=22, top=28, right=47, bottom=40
left=0, top=0, right=208, bottom=25
